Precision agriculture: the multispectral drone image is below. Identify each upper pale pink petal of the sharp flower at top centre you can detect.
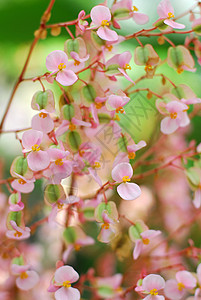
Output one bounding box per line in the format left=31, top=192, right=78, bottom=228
left=90, top=5, right=111, bottom=26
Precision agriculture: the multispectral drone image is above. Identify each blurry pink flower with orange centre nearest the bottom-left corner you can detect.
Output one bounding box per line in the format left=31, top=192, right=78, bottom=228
left=11, top=264, right=39, bottom=291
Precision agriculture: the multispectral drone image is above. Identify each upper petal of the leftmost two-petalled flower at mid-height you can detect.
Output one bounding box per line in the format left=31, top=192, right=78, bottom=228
left=22, top=129, right=43, bottom=150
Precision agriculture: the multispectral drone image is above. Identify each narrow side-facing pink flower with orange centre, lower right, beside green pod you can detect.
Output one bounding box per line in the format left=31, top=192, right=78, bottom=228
left=133, top=230, right=161, bottom=259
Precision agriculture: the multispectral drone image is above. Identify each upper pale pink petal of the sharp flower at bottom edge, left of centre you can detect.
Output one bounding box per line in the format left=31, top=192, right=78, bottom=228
left=54, top=266, right=79, bottom=285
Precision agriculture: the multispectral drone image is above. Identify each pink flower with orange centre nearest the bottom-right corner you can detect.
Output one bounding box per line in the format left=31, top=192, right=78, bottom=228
left=165, top=271, right=196, bottom=300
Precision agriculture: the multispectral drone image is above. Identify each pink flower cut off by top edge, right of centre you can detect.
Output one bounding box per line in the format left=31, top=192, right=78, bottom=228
left=112, top=0, right=149, bottom=25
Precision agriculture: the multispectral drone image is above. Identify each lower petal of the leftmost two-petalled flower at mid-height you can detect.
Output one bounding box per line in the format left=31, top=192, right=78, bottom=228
left=27, top=150, right=50, bottom=171
